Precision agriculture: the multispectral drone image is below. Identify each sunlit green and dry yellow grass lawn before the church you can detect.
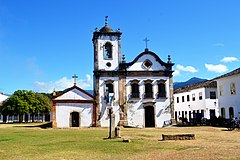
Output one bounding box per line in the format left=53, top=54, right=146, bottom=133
left=0, top=124, right=240, bottom=160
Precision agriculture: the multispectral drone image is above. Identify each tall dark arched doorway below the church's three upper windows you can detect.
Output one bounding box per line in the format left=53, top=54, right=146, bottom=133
left=145, top=106, right=155, bottom=127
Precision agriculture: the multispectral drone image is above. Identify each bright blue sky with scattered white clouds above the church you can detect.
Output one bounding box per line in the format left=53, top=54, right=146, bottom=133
left=0, top=0, right=240, bottom=94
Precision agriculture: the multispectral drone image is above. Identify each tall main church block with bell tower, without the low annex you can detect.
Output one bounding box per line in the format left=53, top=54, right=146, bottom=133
left=92, top=18, right=174, bottom=128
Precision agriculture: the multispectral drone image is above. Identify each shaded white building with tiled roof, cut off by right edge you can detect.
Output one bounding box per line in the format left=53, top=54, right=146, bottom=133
left=214, top=68, right=240, bottom=119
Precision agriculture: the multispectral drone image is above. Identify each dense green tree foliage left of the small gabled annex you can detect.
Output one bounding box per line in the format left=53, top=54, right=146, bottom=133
left=1, top=90, right=52, bottom=115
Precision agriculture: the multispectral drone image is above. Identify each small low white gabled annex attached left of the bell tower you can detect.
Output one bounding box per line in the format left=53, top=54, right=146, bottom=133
left=52, top=84, right=95, bottom=128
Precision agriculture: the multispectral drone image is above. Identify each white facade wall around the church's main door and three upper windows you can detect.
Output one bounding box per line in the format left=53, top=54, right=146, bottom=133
left=126, top=77, right=171, bottom=128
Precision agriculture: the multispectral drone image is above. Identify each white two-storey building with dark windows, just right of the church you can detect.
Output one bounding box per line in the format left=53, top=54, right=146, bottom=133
left=174, top=81, right=219, bottom=121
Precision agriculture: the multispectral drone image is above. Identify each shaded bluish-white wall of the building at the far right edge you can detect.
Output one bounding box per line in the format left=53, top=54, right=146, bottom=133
left=217, top=74, right=240, bottom=119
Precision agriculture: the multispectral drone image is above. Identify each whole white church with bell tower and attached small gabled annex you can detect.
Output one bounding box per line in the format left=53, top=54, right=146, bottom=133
left=53, top=19, right=174, bottom=128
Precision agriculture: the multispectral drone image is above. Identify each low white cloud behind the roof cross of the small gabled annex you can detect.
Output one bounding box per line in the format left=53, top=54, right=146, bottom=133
left=35, top=74, right=92, bottom=93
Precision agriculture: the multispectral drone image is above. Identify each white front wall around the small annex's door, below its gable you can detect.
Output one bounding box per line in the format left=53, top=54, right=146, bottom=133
left=56, top=103, right=93, bottom=128
